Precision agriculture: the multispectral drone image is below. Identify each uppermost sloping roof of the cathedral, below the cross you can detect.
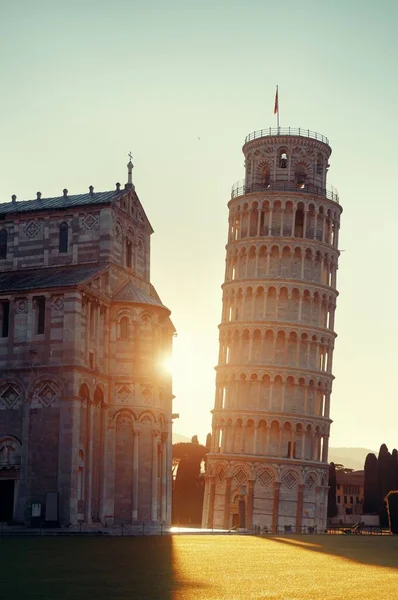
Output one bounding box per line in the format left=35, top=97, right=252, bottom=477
left=0, top=190, right=125, bottom=214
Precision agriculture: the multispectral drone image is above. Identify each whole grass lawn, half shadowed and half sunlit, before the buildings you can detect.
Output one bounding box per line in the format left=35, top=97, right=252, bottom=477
left=0, top=535, right=398, bottom=600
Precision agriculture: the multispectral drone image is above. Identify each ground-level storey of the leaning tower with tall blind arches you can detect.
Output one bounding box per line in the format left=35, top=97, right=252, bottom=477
left=202, top=457, right=329, bottom=533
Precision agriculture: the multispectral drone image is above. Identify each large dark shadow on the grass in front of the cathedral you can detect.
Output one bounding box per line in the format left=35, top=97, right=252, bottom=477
left=0, top=536, right=211, bottom=600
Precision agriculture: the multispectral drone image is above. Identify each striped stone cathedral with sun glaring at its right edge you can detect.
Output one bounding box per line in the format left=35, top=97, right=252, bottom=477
left=0, top=160, right=174, bottom=526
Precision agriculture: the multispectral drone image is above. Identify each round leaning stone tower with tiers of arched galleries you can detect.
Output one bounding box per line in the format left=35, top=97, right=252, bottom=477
left=203, top=128, right=342, bottom=531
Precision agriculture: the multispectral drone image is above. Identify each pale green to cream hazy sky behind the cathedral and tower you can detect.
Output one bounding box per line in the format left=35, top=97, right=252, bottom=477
left=0, top=0, right=398, bottom=448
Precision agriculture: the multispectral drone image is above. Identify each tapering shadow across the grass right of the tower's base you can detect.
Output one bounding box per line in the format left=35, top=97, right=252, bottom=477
left=264, top=535, right=398, bottom=569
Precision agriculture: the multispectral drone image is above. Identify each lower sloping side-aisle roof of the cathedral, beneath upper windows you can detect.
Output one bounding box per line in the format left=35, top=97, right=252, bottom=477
left=0, top=264, right=104, bottom=293
